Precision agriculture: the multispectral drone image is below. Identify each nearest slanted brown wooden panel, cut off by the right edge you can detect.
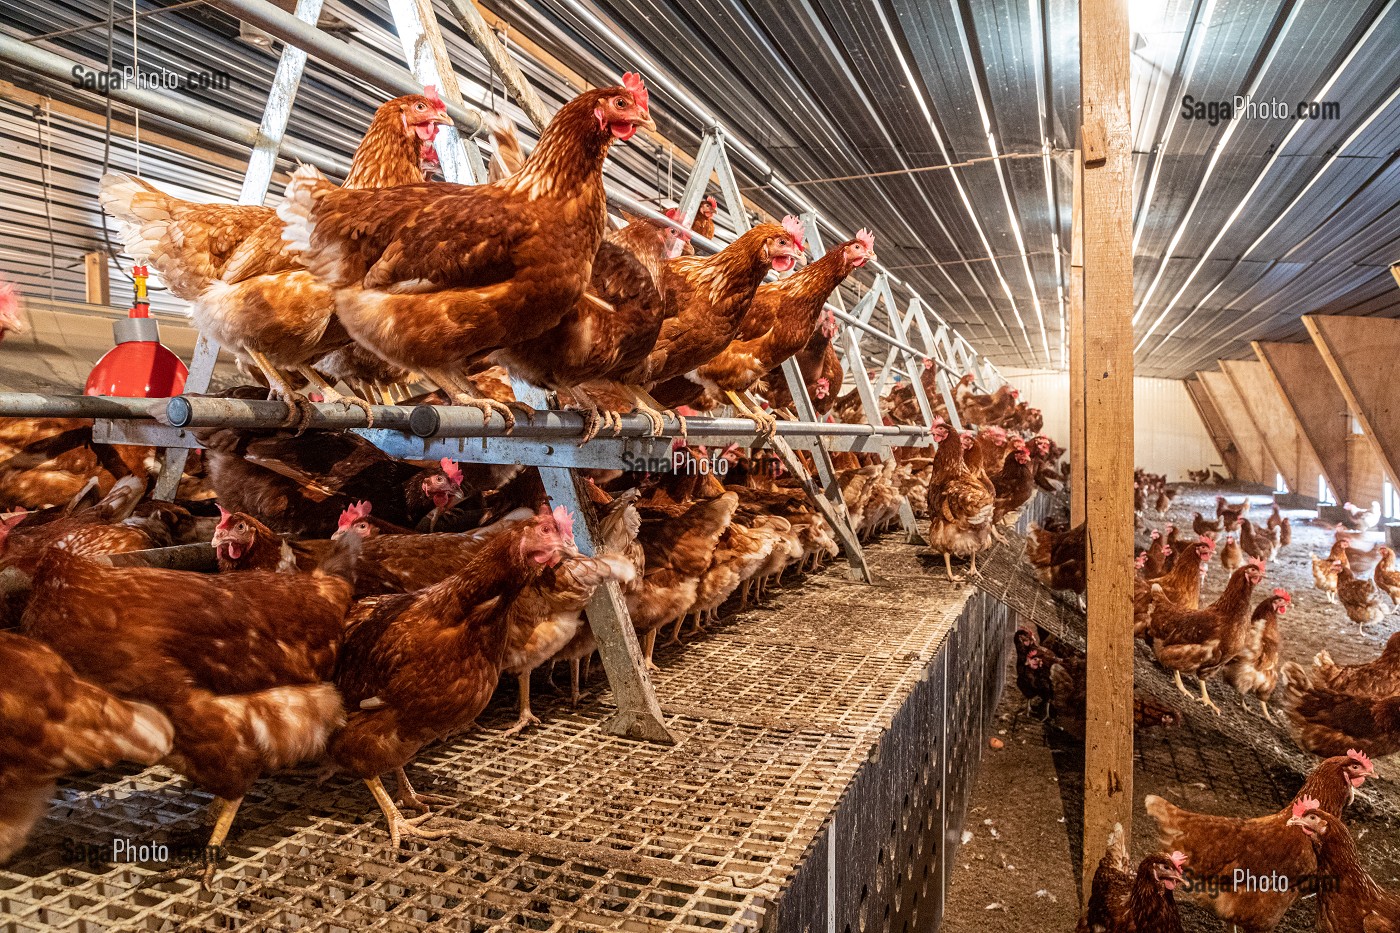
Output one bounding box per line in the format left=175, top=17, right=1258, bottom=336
left=1303, top=314, right=1400, bottom=496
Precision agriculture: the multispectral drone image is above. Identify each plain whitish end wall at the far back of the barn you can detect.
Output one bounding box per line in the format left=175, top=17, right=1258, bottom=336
left=1002, top=368, right=1224, bottom=482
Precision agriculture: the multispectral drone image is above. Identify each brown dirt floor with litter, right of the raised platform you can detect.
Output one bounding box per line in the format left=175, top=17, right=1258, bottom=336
left=944, top=486, right=1400, bottom=933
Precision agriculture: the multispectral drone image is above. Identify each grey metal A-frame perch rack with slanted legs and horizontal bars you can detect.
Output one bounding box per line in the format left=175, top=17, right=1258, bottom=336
left=0, top=0, right=1002, bottom=741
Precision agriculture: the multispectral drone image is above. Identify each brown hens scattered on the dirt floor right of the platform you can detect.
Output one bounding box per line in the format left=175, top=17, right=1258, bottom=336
left=1016, top=481, right=1400, bottom=933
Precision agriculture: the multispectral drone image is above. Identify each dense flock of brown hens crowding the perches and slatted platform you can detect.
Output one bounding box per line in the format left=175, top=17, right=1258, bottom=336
left=0, top=74, right=1063, bottom=883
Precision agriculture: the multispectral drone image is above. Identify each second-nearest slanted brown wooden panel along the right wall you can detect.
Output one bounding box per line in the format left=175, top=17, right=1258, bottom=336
left=1253, top=340, right=1352, bottom=502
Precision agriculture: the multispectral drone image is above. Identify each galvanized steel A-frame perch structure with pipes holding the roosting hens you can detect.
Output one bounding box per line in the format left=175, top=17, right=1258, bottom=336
left=0, top=0, right=1000, bottom=741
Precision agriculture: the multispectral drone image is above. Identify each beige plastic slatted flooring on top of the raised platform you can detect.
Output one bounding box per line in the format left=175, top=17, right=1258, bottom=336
left=0, top=504, right=1041, bottom=933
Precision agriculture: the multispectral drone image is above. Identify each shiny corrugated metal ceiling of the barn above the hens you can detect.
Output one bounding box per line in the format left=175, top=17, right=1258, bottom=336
left=0, top=0, right=1400, bottom=377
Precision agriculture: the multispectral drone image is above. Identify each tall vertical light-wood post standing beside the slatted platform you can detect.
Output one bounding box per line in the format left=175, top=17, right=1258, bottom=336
left=1079, top=0, right=1133, bottom=899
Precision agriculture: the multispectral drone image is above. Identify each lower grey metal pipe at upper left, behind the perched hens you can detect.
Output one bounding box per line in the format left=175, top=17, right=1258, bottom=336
left=0, top=34, right=350, bottom=175
